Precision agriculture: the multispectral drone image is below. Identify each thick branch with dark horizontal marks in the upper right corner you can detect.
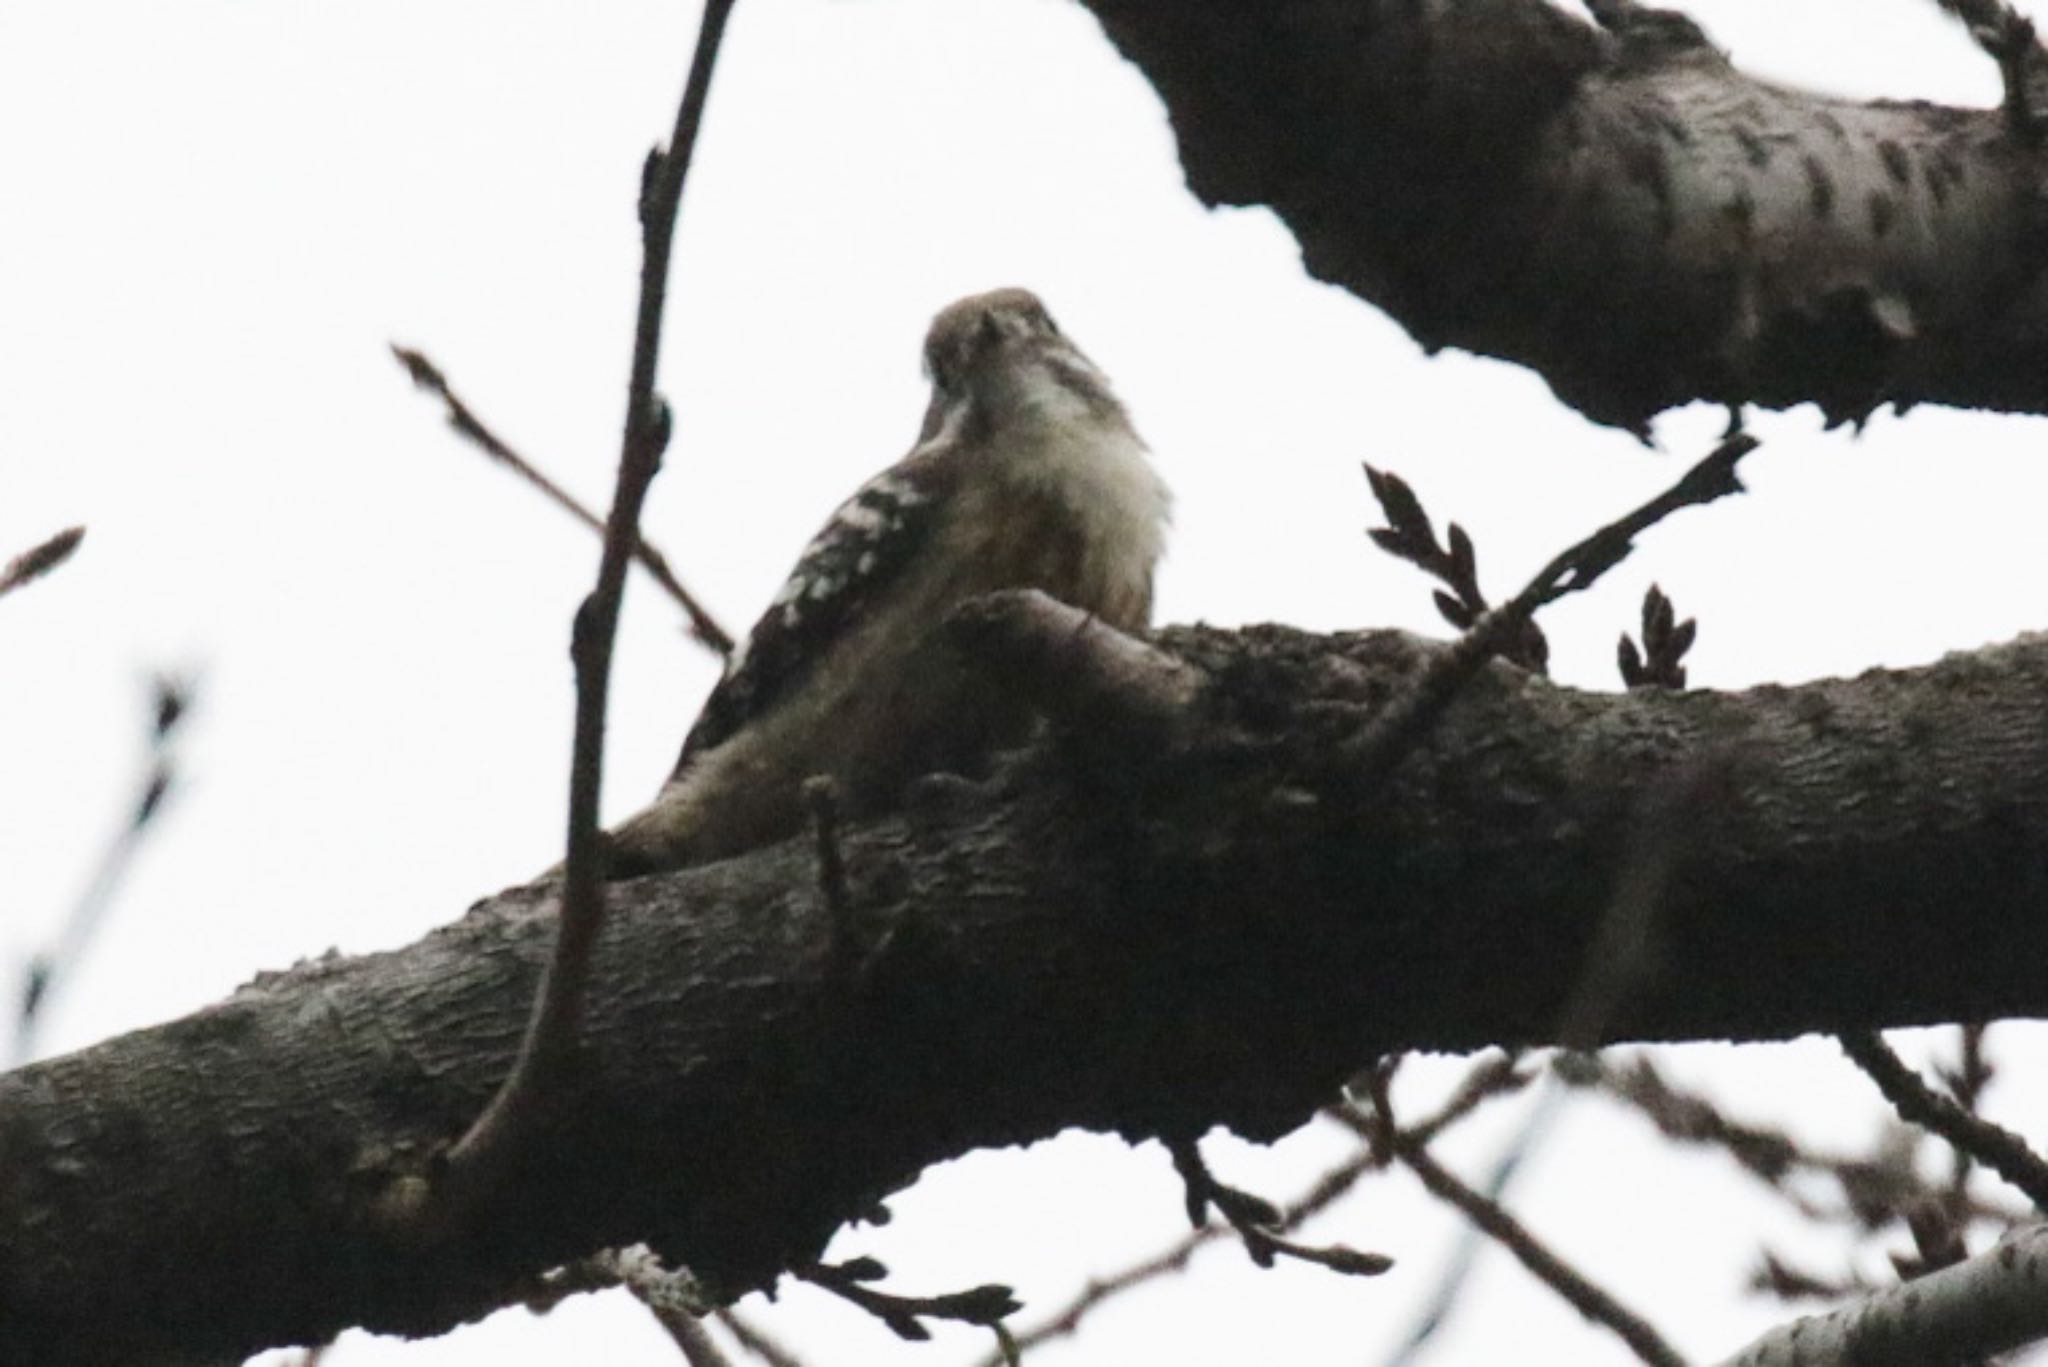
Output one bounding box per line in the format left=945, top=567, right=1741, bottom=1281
left=1085, top=0, right=2048, bottom=430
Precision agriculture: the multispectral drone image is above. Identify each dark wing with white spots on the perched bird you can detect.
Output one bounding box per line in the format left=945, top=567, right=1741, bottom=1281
left=676, top=445, right=950, bottom=775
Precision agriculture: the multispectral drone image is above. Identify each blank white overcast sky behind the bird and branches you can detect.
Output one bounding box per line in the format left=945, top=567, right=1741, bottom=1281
left=0, top=0, right=2048, bottom=1367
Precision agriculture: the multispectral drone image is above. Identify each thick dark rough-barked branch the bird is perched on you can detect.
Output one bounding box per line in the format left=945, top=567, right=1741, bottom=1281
left=0, top=627, right=2048, bottom=1365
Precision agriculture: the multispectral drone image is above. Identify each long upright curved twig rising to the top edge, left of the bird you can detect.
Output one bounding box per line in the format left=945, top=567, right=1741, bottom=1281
left=430, top=0, right=733, bottom=1215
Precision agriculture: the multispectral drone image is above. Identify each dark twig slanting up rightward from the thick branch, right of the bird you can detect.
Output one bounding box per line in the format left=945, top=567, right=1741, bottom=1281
left=1343, top=432, right=1759, bottom=783
